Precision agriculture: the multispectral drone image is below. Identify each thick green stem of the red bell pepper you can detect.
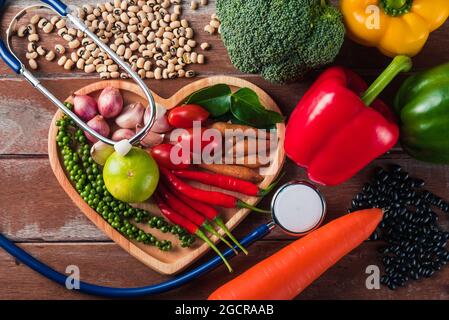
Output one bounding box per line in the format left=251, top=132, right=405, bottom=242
left=361, top=56, right=413, bottom=106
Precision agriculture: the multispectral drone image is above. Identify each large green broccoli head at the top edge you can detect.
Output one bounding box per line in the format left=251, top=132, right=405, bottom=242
left=217, top=0, right=345, bottom=83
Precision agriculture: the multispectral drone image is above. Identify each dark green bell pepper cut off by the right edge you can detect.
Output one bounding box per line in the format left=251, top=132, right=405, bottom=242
left=394, top=63, right=449, bottom=164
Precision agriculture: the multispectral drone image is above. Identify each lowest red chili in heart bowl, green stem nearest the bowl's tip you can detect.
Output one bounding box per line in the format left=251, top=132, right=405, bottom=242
left=153, top=194, right=232, bottom=272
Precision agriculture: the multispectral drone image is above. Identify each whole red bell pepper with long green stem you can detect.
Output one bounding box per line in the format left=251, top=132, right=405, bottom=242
left=285, top=56, right=412, bottom=185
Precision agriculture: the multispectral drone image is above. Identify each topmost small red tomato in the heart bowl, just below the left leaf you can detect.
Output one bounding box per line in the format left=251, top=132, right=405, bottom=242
left=168, top=104, right=209, bottom=129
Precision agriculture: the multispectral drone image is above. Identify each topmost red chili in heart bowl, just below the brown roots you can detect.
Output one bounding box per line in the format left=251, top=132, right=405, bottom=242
left=173, top=170, right=276, bottom=197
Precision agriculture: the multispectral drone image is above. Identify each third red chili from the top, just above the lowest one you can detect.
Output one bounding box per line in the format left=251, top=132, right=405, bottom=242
left=157, top=183, right=238, bottom=254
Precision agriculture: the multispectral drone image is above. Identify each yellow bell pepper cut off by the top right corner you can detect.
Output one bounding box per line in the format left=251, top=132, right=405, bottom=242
left=340, top=0, right=449, bottom=57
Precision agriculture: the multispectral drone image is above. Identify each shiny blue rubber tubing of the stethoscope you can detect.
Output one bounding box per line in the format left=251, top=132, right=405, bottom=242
left=0, top=0, right=273, bottom=298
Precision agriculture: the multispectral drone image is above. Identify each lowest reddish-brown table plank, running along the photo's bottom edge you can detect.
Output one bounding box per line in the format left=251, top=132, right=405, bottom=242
left=0, top=241, right=449, bottom=300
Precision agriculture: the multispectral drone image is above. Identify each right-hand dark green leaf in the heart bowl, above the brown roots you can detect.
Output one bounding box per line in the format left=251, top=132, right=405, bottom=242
left=231, top=88, right=284, bottom=129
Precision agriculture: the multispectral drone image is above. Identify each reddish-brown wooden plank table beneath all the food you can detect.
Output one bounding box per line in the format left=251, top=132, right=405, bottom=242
left=0, top=0, right=449, bottom=299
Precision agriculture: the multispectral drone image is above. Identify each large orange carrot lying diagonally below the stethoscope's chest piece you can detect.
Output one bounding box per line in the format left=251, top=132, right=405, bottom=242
left=209, top=209, right=383, bottom=300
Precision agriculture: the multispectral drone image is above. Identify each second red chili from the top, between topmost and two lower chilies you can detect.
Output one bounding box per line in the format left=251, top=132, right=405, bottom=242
left=160, top=168, right=270, bottom=213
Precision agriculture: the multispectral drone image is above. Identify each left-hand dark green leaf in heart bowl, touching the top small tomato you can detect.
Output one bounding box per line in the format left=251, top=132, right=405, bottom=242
left=184, top=84, right=232, bottom=118
